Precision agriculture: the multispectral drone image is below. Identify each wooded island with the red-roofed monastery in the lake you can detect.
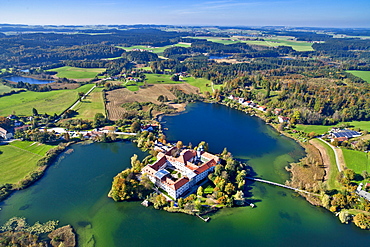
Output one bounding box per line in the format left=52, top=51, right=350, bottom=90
left=109, top=141, right=247, bottom=215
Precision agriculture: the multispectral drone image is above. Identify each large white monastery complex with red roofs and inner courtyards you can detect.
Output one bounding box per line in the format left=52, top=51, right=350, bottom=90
left=142, top=143, right=220, bottom=199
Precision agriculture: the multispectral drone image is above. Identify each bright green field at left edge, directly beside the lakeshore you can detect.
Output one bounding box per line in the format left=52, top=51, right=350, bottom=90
left=0, top=141, right=53, bottom=184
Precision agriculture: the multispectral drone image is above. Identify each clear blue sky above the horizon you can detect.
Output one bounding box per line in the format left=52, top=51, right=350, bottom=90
left=0, top=0, right=370, bottom=27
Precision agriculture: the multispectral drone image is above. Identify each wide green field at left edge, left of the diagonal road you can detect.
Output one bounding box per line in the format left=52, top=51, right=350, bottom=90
left=0, top=84, right=93, bottom=116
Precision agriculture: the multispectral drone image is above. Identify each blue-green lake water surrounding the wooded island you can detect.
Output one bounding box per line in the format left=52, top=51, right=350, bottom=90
left=0, top=103, right=370, bottom=247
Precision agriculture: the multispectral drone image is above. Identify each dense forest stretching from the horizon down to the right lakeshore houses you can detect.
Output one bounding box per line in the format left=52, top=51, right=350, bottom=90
left=0, top=25, right=370, bottom=124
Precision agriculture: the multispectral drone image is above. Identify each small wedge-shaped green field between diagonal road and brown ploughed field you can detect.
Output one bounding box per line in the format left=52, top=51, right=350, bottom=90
left=74, top=87, right=105, bottom=120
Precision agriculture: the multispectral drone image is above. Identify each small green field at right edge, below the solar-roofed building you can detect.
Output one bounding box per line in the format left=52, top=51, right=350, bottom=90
left=342, top=148, right=369, bottom=174
